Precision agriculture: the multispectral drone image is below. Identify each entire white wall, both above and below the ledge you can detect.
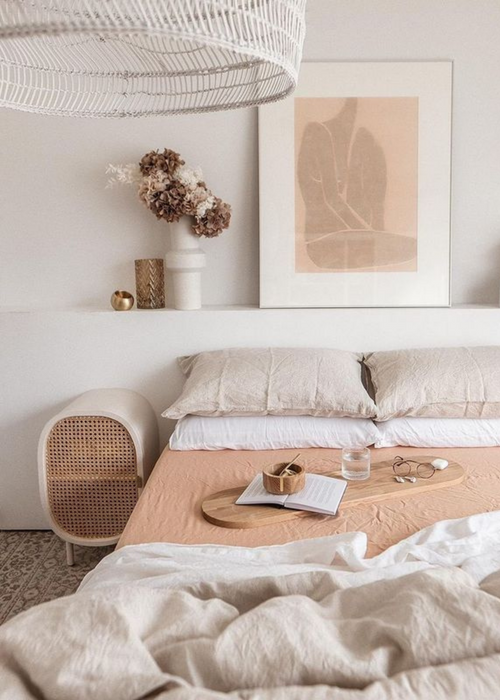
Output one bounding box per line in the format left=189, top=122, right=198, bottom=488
left=0, top=0, right=500, bottom=527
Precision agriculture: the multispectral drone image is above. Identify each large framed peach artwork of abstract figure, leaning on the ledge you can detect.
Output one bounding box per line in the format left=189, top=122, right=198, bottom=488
left=259, top=62, right=452, bottom=307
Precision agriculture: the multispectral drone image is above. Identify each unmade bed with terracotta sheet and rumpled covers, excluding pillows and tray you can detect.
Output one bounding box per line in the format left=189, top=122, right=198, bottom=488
left=0, top=448, right=500, bottom=700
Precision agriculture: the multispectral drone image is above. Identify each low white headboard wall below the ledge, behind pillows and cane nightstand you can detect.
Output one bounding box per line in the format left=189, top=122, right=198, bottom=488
left=0, top=308, right=500, bottom=529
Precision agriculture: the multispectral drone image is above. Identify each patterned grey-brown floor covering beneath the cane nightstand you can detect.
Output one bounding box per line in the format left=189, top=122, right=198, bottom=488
left=0, top=530, right=114, bottom=624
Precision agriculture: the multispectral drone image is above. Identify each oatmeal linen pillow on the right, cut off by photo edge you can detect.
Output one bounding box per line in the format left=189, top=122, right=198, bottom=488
left=365, top=346, right=500, bottom=421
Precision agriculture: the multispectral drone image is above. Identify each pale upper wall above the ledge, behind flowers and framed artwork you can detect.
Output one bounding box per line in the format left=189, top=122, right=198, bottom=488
left=0, top=0, right=500, bottom=308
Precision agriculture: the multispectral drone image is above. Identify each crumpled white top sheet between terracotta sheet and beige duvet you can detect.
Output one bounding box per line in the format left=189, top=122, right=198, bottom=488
left=79, top=511, right=500, bottom=590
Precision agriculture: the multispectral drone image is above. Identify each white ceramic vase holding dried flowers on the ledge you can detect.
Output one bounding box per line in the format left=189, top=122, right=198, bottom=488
left=165, top=216, right=206, bottom=311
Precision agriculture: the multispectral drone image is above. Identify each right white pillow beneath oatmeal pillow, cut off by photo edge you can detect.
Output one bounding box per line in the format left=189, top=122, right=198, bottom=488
left=375, top=418, right=500, bottom=447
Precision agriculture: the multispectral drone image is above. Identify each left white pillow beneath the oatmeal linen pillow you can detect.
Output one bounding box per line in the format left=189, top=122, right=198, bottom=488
left=170, top=416, right=378, bottom=450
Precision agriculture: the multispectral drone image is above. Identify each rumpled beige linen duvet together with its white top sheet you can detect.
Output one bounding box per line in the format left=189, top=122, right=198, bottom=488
left=4, top=512, right=500, bottom=700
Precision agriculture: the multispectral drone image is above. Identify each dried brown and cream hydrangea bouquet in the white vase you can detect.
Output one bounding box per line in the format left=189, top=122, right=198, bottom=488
left=106, top=148, right=231, bottom=238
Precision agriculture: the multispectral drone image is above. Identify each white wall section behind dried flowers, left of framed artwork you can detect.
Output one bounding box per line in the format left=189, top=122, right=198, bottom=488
left=0, top=110, right=258, bottom=308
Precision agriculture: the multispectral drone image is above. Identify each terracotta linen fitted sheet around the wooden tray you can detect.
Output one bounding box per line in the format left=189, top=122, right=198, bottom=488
left=118, top=447, right=500, bottom=556
